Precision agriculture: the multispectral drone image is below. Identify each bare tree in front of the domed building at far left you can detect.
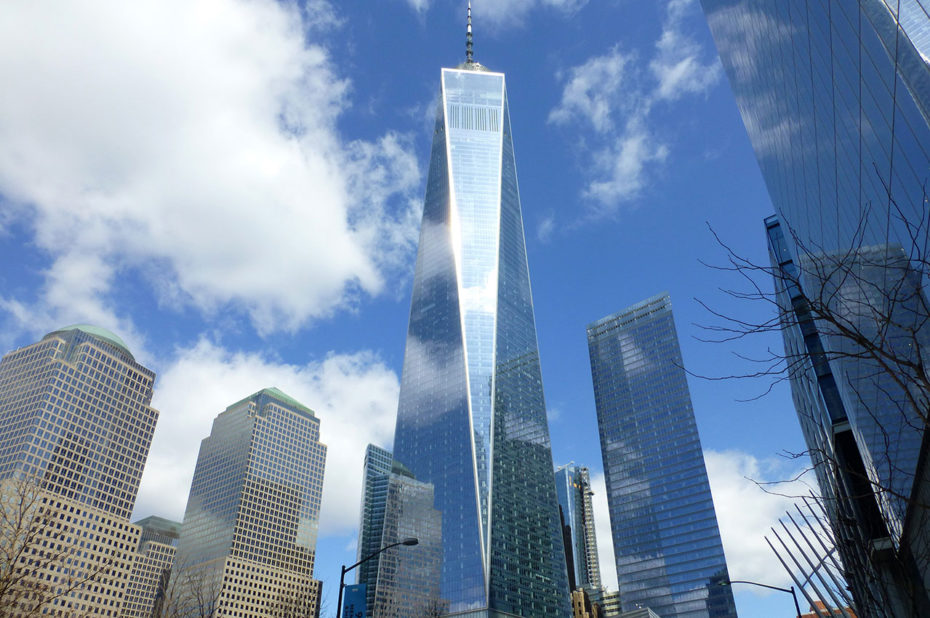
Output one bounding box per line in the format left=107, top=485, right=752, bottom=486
left=0, top=476, right=113, bottom=618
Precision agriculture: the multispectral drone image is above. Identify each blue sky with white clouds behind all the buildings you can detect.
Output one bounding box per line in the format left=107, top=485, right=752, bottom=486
left=0, top=0, right=803, bottom=616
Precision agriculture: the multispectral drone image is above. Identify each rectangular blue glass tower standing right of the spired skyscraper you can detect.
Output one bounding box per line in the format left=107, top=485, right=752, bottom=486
left=588, top=294, right=736, bottom=618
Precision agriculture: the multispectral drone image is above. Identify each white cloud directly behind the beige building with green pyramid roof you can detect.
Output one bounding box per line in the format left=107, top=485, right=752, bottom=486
left=135, top=340, right=399, bottom=535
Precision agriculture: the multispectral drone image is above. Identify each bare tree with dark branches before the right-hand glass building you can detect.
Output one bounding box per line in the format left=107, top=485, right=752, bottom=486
left=698, top=205, right=930, bottom=616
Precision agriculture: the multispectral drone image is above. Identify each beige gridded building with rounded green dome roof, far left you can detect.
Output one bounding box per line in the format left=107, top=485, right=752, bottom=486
left=0, top=325, right=158, bottom=617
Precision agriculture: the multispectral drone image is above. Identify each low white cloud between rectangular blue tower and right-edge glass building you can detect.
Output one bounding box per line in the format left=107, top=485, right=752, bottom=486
left=704, top=450, right=811, bottom=594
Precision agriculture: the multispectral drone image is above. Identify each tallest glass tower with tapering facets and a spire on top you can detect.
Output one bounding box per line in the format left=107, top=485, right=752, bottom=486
left=394, top=6, right=571, bottom=618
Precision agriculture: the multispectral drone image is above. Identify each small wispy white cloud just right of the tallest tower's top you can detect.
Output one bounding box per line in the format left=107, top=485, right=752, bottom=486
left=549, top=47, right=632, bottom=132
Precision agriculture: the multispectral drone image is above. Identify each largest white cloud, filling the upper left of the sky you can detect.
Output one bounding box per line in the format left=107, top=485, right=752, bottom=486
left=0, top=0, right=419, bottom=332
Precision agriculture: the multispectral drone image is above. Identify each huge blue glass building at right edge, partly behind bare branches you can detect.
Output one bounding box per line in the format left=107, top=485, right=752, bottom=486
left=702, top=0, right=930, bottom=616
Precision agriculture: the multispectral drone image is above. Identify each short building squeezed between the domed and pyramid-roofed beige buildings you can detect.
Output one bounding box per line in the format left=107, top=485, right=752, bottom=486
left=120, top=516, right=181, bottom=618
